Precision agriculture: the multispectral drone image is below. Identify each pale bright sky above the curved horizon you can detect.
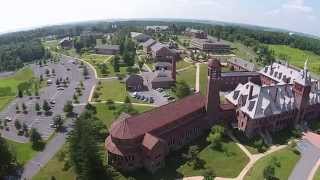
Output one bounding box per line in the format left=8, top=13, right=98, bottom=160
left=0, top=0, right=320, bottom=36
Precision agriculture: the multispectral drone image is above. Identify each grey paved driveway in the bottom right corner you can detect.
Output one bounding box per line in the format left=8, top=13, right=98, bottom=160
left=289, top=139, right=320, bottom=180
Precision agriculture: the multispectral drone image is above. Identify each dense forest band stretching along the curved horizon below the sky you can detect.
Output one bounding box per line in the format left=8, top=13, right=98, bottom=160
left=0, top=21, right=320, bottom=72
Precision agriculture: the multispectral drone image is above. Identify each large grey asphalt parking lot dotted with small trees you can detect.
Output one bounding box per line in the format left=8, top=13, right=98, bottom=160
left=0, top=57, right=96, bottom=142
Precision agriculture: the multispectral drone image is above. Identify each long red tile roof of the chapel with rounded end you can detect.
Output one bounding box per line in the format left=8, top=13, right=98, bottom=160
left=110, top=94, right=205, bottom=139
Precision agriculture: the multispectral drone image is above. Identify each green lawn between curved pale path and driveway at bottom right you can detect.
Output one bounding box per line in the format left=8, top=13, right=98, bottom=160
left=244, top=148, right=300, bottom=180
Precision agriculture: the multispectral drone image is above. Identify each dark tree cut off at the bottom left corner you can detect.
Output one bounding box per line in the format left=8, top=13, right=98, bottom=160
left=0, top=136, right=19, bottom=179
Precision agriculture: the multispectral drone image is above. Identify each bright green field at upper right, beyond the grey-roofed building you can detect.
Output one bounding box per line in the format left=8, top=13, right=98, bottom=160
left=269, top=45, right=320, bottom=75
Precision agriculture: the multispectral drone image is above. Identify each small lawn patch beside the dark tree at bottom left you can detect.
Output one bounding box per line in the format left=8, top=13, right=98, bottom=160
left=6, top=140, right=37, bottom=165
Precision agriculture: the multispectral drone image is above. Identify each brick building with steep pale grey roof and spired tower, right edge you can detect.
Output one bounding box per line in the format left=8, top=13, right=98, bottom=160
left=226, top=60, right=320, bottom=136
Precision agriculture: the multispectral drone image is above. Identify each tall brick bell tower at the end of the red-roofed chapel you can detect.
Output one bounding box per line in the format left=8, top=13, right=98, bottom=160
left=206, top=59, right=221, bottom=124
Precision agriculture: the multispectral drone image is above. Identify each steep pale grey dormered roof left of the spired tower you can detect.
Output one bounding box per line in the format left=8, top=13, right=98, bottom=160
left=226, top=82, right=295, bottom=119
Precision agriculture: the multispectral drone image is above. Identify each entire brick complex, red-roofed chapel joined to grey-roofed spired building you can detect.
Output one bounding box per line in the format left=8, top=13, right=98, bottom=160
left=105, top=60, right=320, bottom=172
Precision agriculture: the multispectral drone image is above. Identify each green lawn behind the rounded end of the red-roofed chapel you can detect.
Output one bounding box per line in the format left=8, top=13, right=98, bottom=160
left=95, top=103, right=152, bottom=128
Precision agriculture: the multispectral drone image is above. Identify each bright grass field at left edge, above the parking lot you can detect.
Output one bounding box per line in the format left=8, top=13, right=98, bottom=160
left=0, top=68, right=34, bottom=111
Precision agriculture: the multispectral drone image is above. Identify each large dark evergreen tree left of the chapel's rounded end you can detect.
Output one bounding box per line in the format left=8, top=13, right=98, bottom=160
left=68, top=111, right=110, bottom=179
